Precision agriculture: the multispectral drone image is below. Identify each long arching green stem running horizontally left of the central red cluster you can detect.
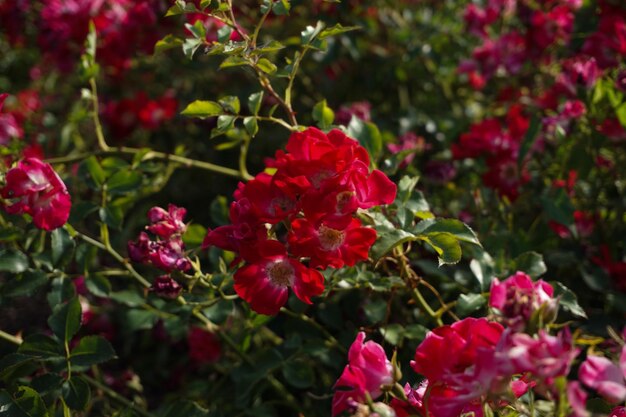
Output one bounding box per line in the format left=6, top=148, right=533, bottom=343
left=44, top=146, right=246, bottom=180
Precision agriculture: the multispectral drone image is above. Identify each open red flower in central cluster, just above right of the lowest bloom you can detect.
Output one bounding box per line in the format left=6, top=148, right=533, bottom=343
left=289, top=219, right=376, bottom=268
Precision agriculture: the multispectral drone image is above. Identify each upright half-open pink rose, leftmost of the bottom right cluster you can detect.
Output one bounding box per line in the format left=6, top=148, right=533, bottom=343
left=332, top=332, right=393, bottom=416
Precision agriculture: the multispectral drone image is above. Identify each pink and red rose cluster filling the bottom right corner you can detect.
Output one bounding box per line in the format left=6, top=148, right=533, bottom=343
left=332, top=272, right=600, bottom=417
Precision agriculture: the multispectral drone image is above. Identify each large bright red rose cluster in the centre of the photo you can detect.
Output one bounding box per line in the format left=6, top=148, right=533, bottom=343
left=204, top=128, right=396, bottom=315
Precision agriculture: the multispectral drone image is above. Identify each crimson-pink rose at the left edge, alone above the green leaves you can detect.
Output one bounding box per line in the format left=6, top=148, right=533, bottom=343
left=0, top=158, right=72, bottom=231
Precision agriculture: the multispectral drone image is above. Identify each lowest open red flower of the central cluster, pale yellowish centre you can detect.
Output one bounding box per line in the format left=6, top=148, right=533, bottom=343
left=234, top=240, right=324, bottom=315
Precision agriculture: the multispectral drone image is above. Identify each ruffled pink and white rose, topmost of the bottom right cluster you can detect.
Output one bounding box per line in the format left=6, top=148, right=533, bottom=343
left=489, top=271, right=557, bottom=328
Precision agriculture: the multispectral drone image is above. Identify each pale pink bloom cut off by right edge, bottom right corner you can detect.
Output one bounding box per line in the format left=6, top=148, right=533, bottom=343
left=578, top=347, right=626, bottom=403
